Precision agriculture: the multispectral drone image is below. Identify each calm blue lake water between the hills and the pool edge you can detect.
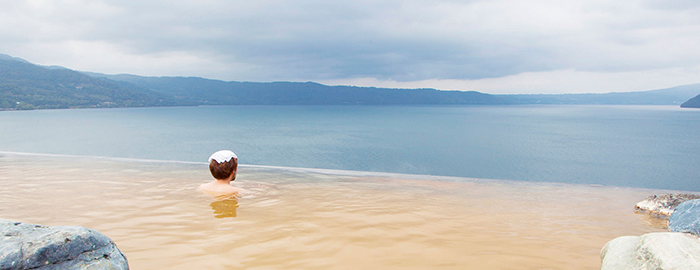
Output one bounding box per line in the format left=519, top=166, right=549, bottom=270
left=0, top=105, right=700, bottom=191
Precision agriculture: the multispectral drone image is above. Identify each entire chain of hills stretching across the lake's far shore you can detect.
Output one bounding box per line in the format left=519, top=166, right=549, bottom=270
left=0, top=54, right=700, bottom=110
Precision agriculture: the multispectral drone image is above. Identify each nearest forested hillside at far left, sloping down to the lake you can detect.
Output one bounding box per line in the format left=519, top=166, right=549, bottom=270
left=0, top=59, right=183, bottom=109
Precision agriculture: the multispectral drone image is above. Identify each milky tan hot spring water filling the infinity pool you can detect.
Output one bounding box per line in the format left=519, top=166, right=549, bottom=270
left=0, top=153, right=664, bottom=269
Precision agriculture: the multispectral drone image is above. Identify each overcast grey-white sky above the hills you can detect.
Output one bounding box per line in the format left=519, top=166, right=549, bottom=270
left=0, top=0, right=700, bottom=94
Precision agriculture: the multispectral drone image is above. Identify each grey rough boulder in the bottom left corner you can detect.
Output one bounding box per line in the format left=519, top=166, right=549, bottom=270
left=0, top=220, right=129, bottom=270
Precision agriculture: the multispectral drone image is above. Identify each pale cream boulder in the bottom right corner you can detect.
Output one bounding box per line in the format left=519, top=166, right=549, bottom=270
left=600, top=232, right=700, bottom=270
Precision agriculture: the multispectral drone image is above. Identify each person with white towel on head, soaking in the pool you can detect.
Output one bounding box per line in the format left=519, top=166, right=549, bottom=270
left=199, top=150, right=246, bottom=196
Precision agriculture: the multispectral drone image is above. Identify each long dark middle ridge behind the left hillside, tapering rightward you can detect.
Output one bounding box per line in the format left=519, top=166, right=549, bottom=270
left=93, top=74, right=509, bottom=105
